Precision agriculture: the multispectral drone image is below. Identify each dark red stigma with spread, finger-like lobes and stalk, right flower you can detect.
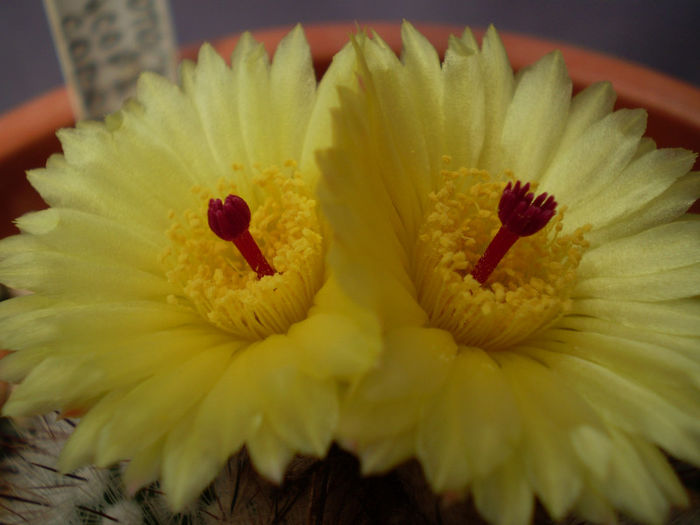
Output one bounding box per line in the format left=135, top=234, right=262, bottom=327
left=471, top=181, right=557, bottom=284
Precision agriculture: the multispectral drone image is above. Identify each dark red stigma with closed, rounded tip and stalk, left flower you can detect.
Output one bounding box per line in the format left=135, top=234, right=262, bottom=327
left=207, top=195, right=276, bottom=279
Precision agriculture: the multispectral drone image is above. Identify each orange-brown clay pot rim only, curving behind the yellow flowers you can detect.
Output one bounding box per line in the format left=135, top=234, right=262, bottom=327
left=0, top=22, right=700, bottom=164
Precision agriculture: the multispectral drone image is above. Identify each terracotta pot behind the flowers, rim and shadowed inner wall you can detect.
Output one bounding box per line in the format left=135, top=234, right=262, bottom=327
left=0, top=22, right=700, bottom=238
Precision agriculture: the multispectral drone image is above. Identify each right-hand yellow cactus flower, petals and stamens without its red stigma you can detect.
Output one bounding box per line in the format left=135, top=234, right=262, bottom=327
left=320, top=24, right=700, bottom=524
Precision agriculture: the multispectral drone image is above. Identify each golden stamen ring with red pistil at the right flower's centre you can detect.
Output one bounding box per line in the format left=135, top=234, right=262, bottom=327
left=413, top=168, right=588, bottom=350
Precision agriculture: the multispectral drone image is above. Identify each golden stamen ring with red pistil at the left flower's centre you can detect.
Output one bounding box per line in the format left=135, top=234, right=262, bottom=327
left=162, top=163, right=325, bottom=340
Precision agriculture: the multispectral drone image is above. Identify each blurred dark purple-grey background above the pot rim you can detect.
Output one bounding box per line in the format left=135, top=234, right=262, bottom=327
left=0, top=0, right=700, bottom=113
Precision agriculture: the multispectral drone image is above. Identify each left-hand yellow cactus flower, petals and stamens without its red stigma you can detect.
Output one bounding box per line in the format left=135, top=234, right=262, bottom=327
left=0, top=27, right=378, bottom=509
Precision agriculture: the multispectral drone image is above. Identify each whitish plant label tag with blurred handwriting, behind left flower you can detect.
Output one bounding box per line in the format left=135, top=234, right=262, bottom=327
left=44, top=0, right=177, bottom=120
